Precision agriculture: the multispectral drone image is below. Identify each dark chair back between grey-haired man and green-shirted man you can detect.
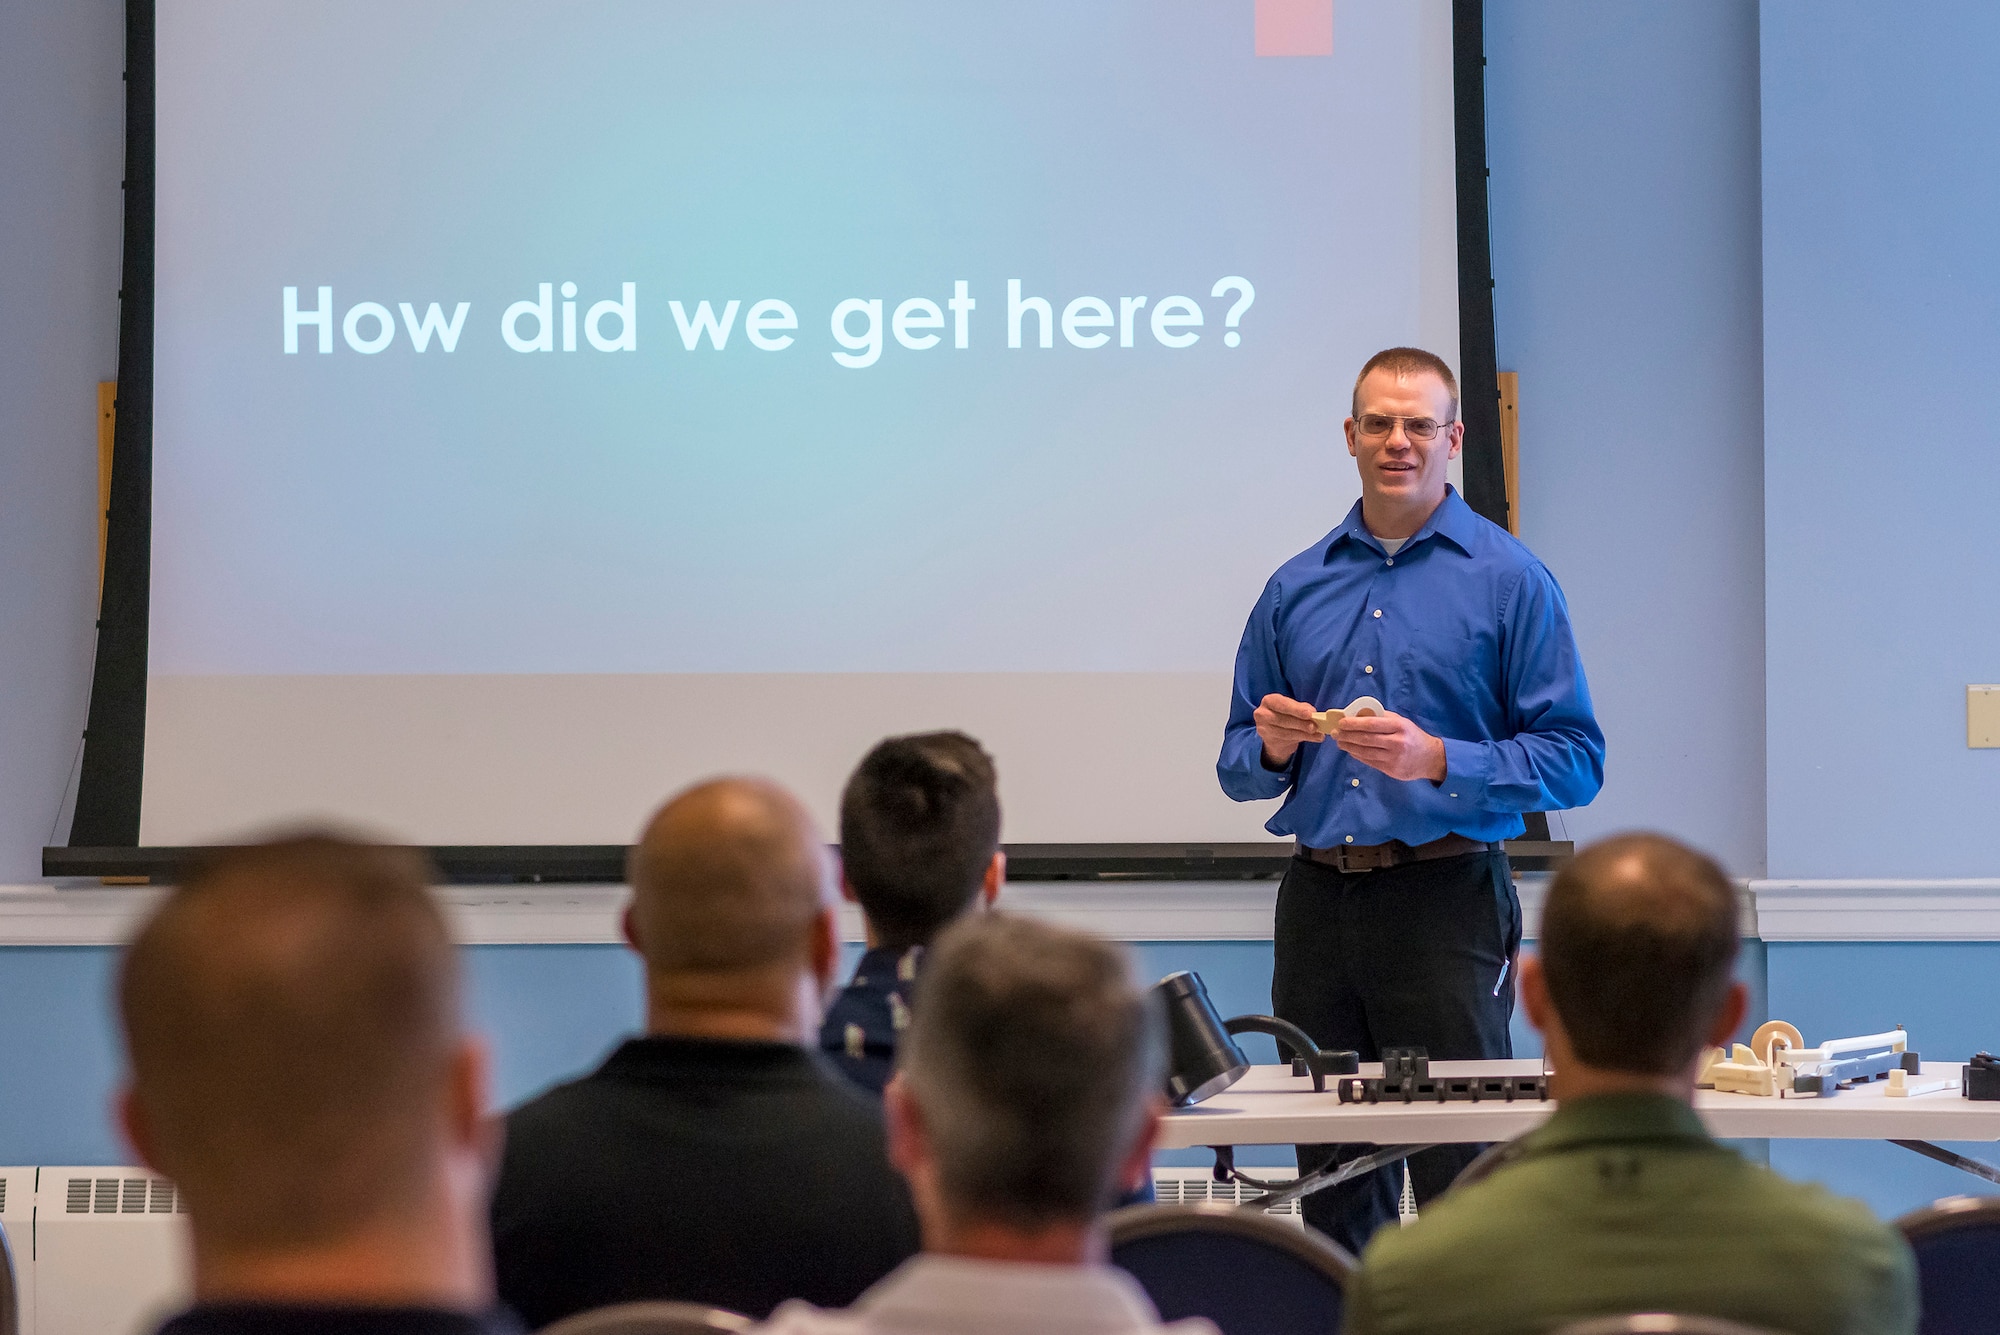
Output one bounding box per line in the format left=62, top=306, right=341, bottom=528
left=1110, top=1201, right=1354, bottom=1335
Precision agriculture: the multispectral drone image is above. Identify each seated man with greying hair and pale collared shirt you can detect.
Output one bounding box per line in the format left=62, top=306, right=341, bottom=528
left=764, top=913, right=1214, bottom=1335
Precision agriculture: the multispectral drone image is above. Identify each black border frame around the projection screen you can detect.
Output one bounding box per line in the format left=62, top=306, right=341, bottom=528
left=42, top=0, right=1504, bottom=881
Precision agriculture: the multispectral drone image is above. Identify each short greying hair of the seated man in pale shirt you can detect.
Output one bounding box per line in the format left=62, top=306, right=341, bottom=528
left=900, top=913, right=1166, bottom=1229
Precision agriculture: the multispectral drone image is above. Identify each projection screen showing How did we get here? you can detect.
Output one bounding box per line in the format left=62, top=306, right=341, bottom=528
left=78, top=0, right=1460, bottom=845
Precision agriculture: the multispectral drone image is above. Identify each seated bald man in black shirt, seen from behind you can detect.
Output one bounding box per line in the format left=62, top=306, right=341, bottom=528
left=492, top=779, right=918, bottom=1327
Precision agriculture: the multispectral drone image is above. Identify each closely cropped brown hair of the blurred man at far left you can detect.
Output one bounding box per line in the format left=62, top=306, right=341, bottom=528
left=118, top=835, right=460, bottom=1247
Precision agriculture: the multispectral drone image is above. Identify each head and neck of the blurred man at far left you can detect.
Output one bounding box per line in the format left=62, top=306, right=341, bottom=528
left=118, top=837, right=518, bottom=1335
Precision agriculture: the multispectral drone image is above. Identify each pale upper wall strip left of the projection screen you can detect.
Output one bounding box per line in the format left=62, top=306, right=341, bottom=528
left=0, top=0, right=124, bottom=883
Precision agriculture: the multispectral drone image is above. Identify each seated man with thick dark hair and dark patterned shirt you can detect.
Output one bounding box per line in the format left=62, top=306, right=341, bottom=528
left=820, top=731, right=1006, bottom=1093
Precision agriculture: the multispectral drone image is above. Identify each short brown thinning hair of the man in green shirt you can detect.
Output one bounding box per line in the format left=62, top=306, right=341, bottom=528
left=1542, top=833, right=1738, bottom=1075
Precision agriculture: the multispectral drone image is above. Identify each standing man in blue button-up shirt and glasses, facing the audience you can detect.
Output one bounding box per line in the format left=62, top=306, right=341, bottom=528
left=1216, top=348, right=1604, bottom=1255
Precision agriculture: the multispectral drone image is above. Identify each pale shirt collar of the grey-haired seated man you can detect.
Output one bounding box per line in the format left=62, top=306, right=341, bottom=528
left=854, top=1253, right=1160, bottom=1335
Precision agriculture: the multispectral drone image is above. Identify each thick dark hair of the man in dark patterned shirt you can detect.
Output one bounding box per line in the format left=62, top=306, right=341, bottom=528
left=840, top=731, right=1000, bottom=949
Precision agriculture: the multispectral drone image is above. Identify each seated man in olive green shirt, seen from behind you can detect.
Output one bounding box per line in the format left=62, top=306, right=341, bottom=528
left=1346, top=835, right=1916, bottom=1335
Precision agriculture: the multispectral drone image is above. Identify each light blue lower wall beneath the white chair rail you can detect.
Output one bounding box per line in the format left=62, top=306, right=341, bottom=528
left=0, top=941, right=2000, bottom=1215
